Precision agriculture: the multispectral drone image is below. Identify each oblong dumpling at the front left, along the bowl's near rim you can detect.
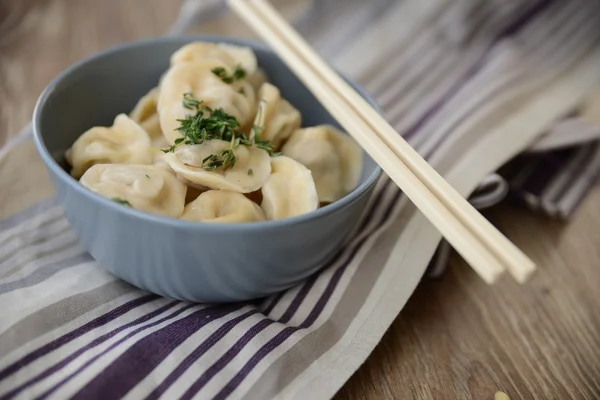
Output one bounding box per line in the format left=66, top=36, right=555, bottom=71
left=80, top=164, right=187, bottom=218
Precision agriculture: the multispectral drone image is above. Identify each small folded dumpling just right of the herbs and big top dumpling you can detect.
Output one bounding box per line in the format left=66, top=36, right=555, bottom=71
left=254, top=82, right=301, bottom=149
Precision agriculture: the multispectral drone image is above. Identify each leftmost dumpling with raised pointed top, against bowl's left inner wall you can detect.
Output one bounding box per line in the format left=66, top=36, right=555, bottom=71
left=65, top=114, right=152, bottom=178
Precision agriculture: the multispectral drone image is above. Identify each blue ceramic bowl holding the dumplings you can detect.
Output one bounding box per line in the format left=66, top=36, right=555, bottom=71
left=34, top=36, right=381, bottom=302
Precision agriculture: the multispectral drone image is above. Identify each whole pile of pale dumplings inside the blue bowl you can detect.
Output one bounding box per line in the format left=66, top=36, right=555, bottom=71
left=65, top=42, right=362, bottom=223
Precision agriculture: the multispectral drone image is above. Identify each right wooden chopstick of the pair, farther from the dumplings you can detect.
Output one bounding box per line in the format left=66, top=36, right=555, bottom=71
left=241, top=0, right=535, bottom=283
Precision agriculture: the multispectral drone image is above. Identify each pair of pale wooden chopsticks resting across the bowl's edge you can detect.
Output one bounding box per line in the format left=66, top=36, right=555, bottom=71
left=228, top=0, right=535, bottom=284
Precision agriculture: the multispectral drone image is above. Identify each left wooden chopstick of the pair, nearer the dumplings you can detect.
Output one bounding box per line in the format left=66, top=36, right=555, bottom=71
left=230, top=0, right=528, bottom=283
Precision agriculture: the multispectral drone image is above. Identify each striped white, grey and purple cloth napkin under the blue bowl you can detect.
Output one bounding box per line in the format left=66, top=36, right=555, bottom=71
left=0, top=0, right=600, bottom=400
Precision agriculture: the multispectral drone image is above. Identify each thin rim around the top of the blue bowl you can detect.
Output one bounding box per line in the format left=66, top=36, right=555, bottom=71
left=33, top=35, right=383, bottom=232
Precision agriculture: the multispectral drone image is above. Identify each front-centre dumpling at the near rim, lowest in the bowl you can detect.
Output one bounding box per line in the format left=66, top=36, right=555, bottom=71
left=181, top=190, right=265, bottom=222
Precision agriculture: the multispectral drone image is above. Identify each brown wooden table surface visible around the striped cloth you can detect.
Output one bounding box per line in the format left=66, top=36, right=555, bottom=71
left=0, top=0, right=600, bottom=400
